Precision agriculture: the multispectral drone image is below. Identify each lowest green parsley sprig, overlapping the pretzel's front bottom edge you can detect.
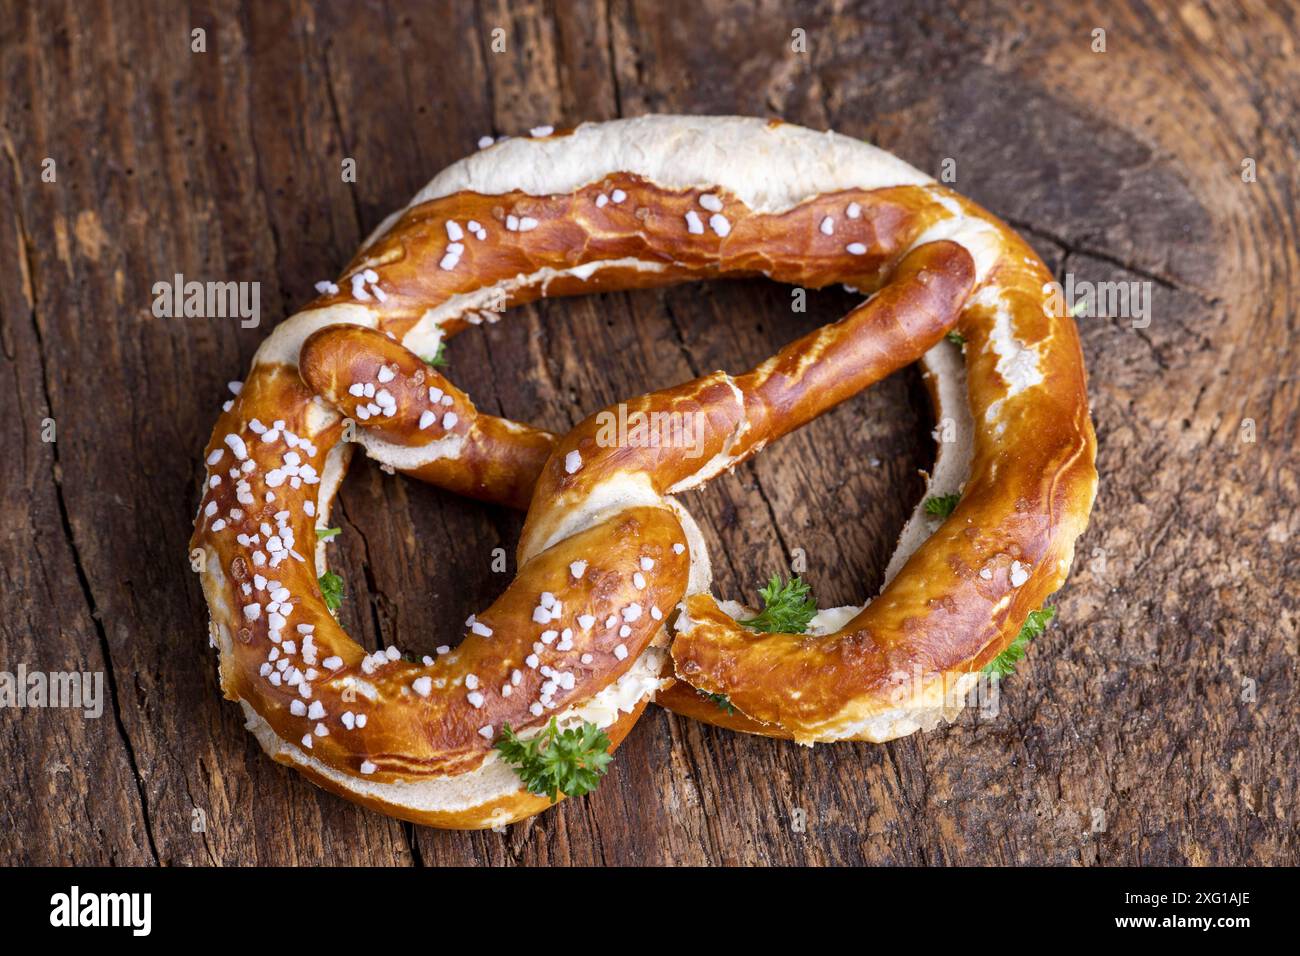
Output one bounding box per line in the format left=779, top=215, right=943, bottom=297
left=497, top=717, right=614, bottom=804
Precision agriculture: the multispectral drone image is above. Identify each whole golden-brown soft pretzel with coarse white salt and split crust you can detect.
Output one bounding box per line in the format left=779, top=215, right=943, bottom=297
left=191, top=116, right=1096, bottom=827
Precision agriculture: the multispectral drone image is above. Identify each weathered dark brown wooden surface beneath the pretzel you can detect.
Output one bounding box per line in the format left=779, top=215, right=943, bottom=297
left=0, top=0, right=1300, bottom=865
